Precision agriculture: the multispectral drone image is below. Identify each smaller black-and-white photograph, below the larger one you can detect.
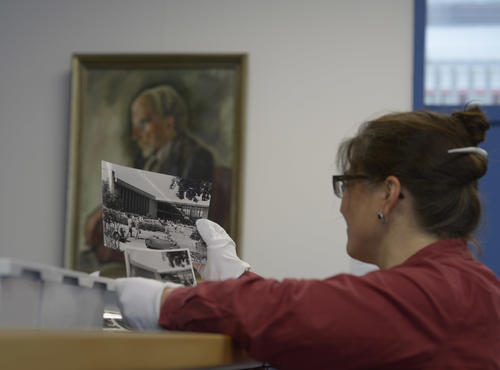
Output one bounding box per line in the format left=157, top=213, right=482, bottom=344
left=125, top=247, right=196, bottom=286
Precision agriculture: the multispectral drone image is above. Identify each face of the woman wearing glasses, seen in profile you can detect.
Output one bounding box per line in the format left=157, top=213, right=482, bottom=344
left=340, top=180, right=381, bottom=263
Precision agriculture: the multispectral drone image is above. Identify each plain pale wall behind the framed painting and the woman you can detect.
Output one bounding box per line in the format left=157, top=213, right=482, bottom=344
left=0, top=0, right=413, bottom=278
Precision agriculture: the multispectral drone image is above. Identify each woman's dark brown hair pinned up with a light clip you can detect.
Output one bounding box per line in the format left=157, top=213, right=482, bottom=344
left=337, top=105, right=490, bottom=240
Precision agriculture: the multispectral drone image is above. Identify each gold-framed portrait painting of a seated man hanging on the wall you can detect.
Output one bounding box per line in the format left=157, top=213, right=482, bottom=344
left=65, top=54, right=247, bottom=276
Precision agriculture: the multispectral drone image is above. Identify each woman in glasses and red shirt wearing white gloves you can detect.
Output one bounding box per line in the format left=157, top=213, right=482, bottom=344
left=118, top=106, right=500, bottom=369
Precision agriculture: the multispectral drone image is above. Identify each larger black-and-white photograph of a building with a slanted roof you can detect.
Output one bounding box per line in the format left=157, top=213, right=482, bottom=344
left=101, top=161, right=212, bottom=264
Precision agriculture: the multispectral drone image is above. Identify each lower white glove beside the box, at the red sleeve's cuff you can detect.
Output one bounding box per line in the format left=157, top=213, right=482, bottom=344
left=115, top=277, right=183, bottom=330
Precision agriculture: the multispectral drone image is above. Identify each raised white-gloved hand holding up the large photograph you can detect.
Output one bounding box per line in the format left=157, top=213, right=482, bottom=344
left=196, top=219, right=250, bottom=281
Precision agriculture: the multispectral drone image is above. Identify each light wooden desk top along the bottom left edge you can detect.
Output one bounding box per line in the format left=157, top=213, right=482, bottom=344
left=0, top=331, right=262, bottom=370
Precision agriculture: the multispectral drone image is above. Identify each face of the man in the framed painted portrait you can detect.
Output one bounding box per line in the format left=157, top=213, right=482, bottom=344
left=131, top=96, right=164, bottom=158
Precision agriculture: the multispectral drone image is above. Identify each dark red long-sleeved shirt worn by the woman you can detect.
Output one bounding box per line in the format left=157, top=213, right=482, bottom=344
left=159, top=239, right=500, bottom=370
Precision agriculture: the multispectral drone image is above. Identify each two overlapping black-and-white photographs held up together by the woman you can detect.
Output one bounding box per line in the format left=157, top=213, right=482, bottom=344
left=102, top=161, right=212, bottom=285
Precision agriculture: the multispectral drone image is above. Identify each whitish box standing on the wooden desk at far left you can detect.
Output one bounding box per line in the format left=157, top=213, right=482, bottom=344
left=0, top=258, right=115, bottom=329
